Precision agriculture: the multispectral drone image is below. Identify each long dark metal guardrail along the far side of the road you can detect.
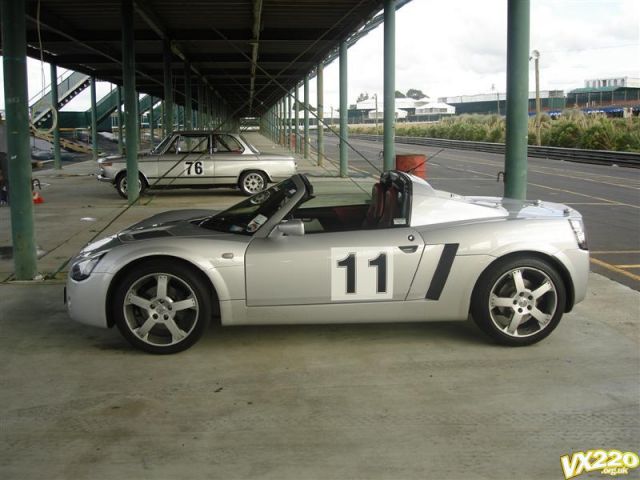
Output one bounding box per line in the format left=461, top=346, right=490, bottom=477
left=349, top=134, right=640, bottom=168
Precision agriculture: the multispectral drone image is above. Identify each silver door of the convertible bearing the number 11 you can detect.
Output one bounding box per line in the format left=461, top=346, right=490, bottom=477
left=245, top=227, right=424, bottom=307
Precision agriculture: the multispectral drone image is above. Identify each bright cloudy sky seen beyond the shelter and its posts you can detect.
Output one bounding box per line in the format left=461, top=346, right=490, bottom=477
left=0, top=0, right=640, bottom=115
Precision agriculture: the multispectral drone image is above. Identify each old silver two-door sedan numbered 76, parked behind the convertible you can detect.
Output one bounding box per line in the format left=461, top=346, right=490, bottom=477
left=98, top=130, right=296, bottom=198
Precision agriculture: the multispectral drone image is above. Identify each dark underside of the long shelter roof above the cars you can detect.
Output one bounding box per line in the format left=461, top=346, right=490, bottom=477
left=13, top=0, right=383, bottom=116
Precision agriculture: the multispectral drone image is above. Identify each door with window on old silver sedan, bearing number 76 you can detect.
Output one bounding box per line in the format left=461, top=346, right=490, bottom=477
left=158, top=133, right=214, bottom=186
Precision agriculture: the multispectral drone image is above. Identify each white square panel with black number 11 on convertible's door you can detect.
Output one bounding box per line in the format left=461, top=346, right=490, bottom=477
left=331, top=247, right=393, bottom=302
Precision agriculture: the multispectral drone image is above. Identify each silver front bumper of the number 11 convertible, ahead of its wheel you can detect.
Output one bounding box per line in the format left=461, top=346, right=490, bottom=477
left=65, top=272, right=113, bottom=328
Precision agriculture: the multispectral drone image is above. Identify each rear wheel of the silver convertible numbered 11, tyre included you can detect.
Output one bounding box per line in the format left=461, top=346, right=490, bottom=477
left=471, top=257, right=566, bottom=346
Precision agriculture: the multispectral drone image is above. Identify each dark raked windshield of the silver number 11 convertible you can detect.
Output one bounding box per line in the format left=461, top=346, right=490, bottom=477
left=200, top=179, right=298, bottom=235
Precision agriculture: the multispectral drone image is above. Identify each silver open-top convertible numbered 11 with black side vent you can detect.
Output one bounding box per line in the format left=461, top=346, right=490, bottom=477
left=65, top=171, right=589, bottom=353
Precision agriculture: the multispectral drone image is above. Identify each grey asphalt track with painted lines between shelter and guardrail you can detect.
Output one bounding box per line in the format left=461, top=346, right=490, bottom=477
left=325, top=134, right=640, bottom=290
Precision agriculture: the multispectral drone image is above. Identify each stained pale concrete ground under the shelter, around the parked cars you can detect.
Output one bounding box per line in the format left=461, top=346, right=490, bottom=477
left=0, top=135, right=640, bottom=479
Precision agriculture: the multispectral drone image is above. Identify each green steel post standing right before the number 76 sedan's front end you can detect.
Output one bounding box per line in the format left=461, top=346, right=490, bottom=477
left=122, top=0, right=140, bottom=205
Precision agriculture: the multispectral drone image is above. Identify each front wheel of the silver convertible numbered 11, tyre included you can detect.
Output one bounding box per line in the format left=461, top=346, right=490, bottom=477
left=112, top=260, right=212, bottom=354
